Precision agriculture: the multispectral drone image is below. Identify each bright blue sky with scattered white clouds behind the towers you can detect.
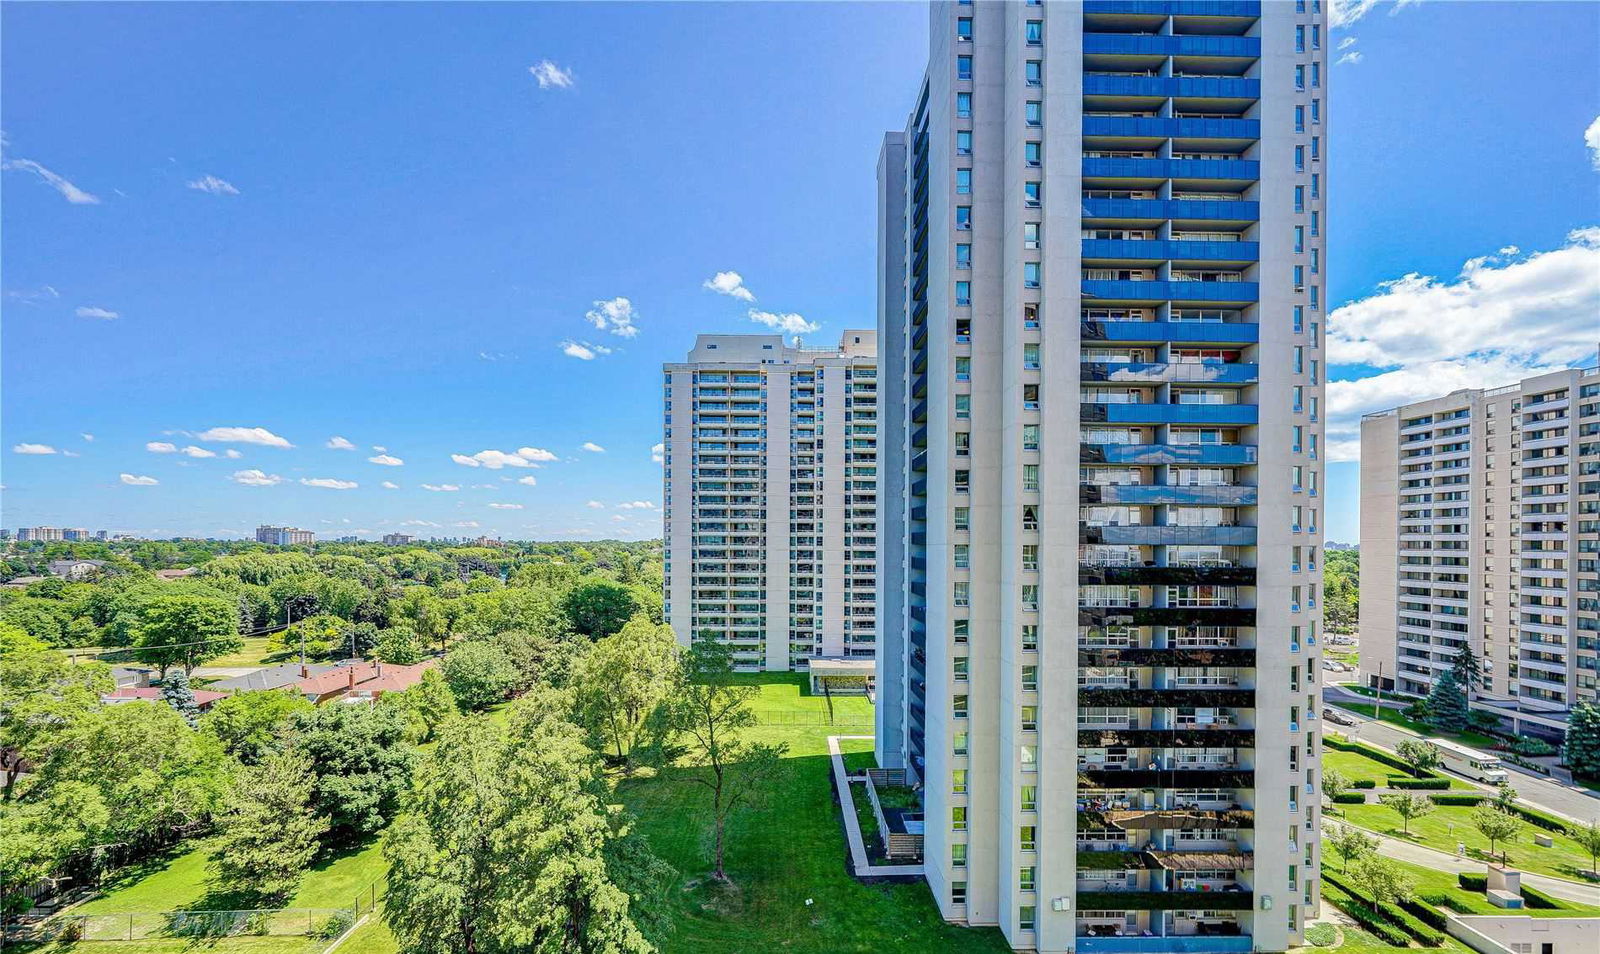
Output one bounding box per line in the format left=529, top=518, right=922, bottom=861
left=0, top=2, right=1600, bottom=539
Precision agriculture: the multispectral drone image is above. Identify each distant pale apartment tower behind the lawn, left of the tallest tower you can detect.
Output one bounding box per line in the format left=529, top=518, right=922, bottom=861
left=662, top=331, right=878, bottom=671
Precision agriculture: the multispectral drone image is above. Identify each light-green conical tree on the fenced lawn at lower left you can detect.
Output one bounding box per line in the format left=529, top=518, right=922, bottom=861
left=211, top=752, right=328, bottom=898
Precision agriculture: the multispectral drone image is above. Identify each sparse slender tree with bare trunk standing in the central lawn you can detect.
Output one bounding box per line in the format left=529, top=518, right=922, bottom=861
left=667, top=640, right=787, bottom=880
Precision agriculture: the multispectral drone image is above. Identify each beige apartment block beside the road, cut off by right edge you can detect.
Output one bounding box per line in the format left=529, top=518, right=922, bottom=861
left=1360, top=361, right=1600, bottom=741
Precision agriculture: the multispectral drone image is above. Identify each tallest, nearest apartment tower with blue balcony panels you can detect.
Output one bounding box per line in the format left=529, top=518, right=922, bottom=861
left=877, top=0, right=1330, bottom=954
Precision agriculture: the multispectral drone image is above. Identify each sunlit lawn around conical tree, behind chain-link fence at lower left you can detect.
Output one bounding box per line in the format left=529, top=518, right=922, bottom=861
left=72, top=839, right=384, bottom=914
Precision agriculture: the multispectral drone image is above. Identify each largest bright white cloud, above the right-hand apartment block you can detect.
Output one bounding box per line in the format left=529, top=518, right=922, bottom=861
left=1328, top=227, right=1600, bottom=461
